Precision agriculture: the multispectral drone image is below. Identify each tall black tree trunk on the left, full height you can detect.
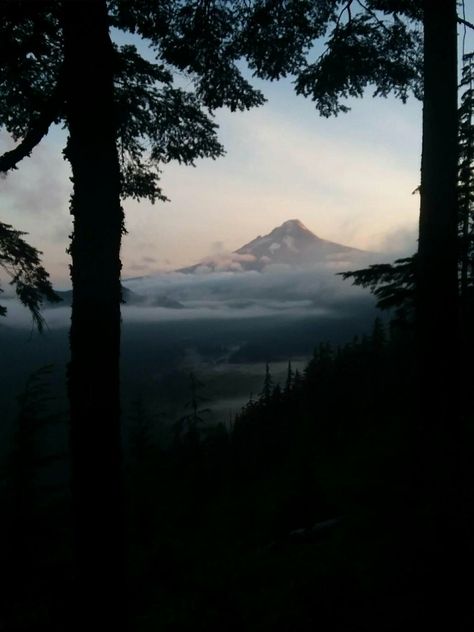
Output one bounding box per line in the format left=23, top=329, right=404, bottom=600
left=63, top=0, right=126, bottom=631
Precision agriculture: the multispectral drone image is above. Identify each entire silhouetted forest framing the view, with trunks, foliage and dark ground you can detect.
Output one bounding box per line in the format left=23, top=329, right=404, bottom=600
left=0, top=0, right=474, bottom=632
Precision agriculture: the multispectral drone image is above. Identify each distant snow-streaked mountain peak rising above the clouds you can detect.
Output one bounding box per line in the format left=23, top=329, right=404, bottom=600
left=179, top=219, right=363, bottom=273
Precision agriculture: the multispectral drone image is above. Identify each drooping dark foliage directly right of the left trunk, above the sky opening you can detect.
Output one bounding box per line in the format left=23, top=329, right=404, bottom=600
left=115, top=45, right=223, bottom=202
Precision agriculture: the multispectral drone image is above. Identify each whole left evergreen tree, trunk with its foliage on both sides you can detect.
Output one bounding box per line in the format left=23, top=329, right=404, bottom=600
left=0, top=0, right=263, bottom=629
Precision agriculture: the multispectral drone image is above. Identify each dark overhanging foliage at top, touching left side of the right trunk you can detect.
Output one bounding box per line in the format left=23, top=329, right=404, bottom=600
left=231, top=0, right=423, bottom=116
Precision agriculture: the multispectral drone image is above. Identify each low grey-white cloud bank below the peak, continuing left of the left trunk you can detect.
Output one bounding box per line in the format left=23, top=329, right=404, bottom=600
left=2, top=257, right=382, bottom=328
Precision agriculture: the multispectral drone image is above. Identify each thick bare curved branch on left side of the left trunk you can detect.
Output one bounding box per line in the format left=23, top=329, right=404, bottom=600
left=0, top=72, right=63, bottom=173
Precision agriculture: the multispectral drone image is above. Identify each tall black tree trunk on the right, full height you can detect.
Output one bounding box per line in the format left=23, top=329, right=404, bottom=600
left=413, top=0, right=467, bottom=630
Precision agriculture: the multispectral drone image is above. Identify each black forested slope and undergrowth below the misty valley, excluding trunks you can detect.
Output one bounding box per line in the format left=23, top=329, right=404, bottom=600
left=1, top=320, right=474, bottom=631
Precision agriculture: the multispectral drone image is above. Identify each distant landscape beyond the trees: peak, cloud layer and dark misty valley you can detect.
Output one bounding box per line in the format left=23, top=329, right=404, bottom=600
left=0, top=219, right=380, bottom=430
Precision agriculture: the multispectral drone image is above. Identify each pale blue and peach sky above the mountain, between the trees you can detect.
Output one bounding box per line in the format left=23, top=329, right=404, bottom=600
left=0, top=9, right=470, bottom=288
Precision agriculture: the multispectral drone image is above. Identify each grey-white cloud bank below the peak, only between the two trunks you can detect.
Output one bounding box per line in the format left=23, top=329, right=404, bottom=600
left=124, top=257, right=373, bottom=320
